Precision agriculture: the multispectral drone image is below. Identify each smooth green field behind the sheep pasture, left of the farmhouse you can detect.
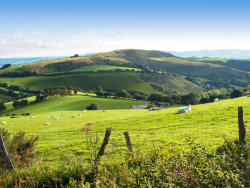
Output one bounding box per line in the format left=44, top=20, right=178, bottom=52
left=5, top=95, right=149, bottom=115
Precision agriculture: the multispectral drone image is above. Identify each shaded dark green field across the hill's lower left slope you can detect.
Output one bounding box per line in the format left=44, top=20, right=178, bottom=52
left=0, top=72, right=155, bottom=94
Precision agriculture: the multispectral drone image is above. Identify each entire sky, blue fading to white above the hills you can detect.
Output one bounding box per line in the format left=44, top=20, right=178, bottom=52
left=0, top=0, right=250, bottom=57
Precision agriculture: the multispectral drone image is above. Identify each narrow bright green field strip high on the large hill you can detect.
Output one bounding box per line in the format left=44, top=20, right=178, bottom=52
left=71, top=65, right=141, bottom=72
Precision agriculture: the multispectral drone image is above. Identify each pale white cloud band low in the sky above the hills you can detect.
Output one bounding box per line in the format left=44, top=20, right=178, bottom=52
left=0, top=28, right=250, bottom=57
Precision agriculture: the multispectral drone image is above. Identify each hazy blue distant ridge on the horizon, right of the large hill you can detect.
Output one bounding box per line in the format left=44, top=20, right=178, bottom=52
left=167, top=49, right=250, bottom=59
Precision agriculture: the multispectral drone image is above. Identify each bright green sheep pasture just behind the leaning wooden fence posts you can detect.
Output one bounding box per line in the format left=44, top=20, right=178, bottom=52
left=1, top=97, right=250, bottom=163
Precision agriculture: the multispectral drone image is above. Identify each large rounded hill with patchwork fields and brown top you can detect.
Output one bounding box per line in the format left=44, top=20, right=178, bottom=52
left=0, top=49, right=249, bottom=98
